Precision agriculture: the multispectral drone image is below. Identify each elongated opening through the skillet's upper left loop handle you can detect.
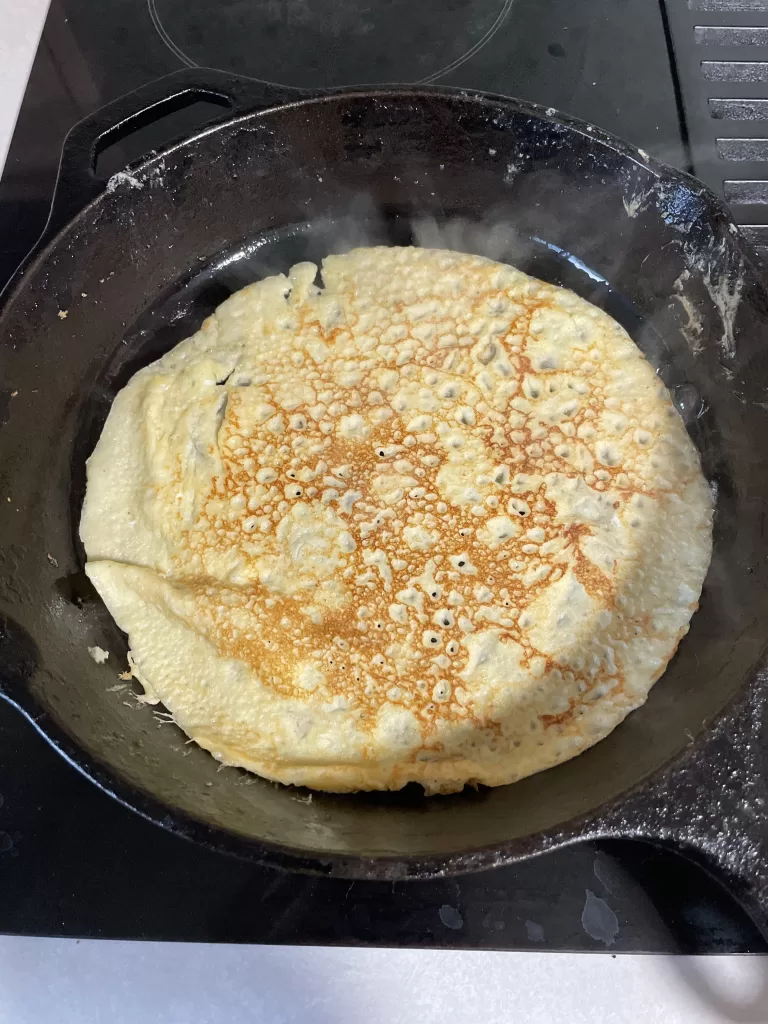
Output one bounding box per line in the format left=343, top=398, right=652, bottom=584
left=93, top=89, right=232, bottom=180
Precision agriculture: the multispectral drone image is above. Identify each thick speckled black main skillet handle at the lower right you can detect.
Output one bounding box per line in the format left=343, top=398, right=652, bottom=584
left=594, top=671, right=768, bottom=943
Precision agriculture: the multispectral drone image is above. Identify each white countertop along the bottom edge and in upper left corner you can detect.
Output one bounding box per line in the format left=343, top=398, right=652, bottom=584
left=0, top=0, right=768, bottom=1024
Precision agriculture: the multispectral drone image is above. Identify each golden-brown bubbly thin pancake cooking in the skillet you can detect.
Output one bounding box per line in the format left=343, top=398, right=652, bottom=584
left=81, top=248, right=712, bottom=793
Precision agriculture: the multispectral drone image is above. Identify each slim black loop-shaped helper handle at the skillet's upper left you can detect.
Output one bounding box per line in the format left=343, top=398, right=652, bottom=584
left=44, top=68, right=313, bottom=241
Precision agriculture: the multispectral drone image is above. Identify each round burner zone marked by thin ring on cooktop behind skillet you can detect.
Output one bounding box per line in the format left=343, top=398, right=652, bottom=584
left=147, top=0, right=514, bottom=88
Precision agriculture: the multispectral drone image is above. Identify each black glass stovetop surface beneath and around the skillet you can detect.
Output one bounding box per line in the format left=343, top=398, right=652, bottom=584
left=0, top=0, right=768, bottom=952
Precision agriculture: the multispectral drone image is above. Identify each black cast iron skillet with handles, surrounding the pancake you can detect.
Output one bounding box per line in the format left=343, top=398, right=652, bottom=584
left=0, top=71, right=768, bottom=931
